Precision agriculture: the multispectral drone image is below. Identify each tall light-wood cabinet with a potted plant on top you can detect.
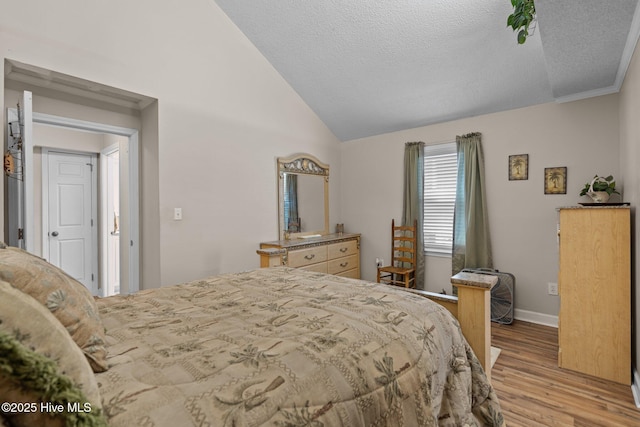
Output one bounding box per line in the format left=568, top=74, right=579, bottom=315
left=558, top=206, right=631, bottom=385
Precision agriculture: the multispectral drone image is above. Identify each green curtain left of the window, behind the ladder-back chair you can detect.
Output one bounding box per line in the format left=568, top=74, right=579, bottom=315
left=402, top=142, right=424, bottom=289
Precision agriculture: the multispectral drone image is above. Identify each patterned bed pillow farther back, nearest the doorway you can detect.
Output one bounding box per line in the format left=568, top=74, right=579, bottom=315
left=0, top=246, right=107, bottom=372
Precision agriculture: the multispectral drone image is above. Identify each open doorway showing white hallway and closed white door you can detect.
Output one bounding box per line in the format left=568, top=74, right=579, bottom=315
left=40, top=137, right=128, bottom=297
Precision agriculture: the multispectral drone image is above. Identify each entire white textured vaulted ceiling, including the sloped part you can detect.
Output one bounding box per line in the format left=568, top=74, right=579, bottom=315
left=215, top=0, right=640, bottom=141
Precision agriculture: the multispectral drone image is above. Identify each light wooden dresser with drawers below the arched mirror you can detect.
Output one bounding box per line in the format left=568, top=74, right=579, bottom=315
left=257, top=233, right=360, bottom=279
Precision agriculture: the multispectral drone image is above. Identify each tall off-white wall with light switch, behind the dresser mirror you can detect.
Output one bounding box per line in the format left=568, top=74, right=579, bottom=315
left=0, top=0, right=341, bottom=287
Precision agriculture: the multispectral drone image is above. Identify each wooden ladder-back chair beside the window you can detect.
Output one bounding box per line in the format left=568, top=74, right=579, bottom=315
left=378, top=220, right=418, bottom=288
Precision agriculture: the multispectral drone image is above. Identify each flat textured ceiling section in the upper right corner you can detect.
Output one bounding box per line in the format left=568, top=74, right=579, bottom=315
left=536, top=0, right=639, bottom=101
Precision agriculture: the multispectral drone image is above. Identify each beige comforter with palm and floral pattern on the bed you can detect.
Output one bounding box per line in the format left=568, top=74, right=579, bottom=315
left=96, top=267, right=504, bottom=427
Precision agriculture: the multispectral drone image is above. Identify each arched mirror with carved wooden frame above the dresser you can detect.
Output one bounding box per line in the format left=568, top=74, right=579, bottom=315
left=278, top=154, right=329, bottom=240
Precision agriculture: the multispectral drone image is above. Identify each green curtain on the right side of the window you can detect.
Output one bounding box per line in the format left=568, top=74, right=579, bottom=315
left=451, top=133, right=493, bottom=275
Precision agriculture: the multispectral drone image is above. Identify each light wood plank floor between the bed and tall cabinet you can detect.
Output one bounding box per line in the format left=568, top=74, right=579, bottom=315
left=491, top=320, right=640, bottom=427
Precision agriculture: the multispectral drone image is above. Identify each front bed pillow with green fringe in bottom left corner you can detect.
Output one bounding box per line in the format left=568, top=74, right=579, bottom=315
left=0, top=281, right=102, bottom=426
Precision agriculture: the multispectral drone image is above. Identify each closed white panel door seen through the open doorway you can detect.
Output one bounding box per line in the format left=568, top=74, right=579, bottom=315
left=43, top=150, right=98, bottom=295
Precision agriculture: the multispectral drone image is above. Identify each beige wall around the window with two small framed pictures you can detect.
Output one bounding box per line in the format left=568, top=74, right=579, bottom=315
left=342, top=95, right=622, bottom=322
